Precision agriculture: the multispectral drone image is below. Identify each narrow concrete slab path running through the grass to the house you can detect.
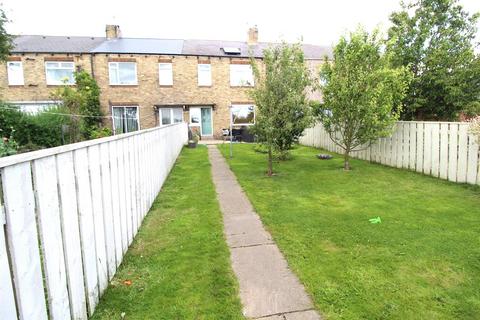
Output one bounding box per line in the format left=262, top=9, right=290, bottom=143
left=208, top=145, right=320, bottom=320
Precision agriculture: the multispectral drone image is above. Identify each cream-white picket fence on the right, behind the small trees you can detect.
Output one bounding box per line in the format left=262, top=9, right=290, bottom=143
left=300, top=121, right=480, bottom=184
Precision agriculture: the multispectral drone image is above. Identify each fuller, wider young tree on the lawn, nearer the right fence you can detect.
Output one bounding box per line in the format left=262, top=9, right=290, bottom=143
left=317, top=29, right=409, bottom=170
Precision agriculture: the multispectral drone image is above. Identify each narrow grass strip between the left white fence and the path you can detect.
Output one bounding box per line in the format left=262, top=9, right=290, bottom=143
left=93, top=147, right=243, bottom=320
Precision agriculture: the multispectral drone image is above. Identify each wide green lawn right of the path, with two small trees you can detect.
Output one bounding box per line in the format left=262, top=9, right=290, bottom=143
left=219, top=144, right=480, bottom=320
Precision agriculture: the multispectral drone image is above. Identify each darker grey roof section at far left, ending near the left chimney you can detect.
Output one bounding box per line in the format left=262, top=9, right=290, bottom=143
left=12, top=36, right=106, bottom=53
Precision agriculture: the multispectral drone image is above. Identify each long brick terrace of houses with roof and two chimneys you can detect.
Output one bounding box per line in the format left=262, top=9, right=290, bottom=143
left=0, top=25, right=331, bottom=139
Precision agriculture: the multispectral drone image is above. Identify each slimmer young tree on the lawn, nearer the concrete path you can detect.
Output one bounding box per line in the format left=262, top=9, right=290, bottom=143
left=251, top=43, right=311, bottom=176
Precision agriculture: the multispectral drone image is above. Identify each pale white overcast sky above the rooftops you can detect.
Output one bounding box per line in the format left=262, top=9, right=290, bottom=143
left=0, top=0, right=480, bottom=45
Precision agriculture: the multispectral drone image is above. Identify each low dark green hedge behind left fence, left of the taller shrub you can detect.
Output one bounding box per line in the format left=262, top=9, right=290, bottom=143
left=0, top=103, right=70, bottom=152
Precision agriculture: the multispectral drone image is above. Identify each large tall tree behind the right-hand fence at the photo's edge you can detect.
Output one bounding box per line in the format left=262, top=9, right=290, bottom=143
left=388, top=0, right=480, bottom=120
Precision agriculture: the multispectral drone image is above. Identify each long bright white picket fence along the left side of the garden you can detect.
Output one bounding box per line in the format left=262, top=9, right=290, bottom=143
left=0, top=123, right=187, bottom=320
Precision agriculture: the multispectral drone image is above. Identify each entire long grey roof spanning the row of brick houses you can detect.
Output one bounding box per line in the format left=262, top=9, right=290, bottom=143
left=12, top=36, right=332, bottom=59
